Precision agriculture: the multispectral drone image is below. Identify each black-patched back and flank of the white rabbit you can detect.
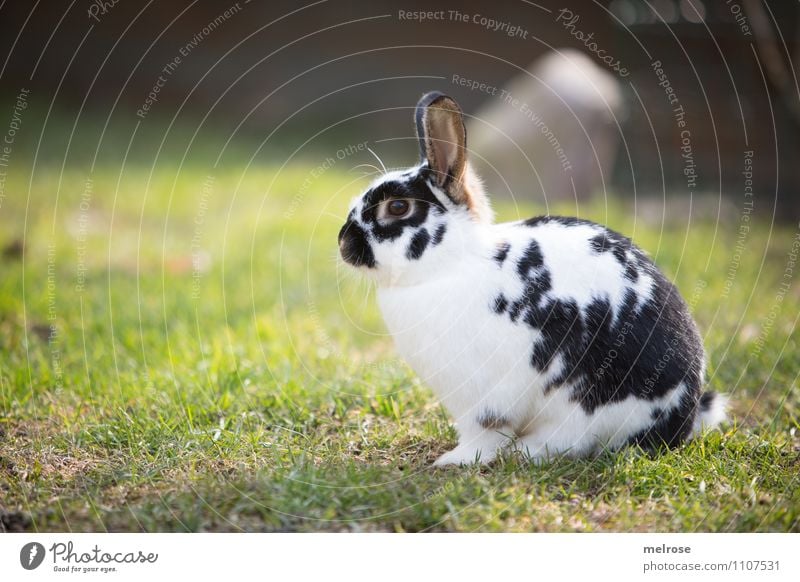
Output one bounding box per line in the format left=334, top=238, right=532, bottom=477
left=494, top=217, right=704, bottom=443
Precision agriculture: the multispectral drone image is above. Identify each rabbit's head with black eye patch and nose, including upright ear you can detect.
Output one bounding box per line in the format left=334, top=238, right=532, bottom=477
left=339, top=92, right=492, bottom=285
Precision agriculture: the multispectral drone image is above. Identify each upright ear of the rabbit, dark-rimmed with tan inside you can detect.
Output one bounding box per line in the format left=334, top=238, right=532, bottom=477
left=415, top=91, right=467, bottom=204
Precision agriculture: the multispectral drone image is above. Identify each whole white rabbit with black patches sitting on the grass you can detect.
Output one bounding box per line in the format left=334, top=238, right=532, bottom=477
left=338, top=92, right=727, bottom=466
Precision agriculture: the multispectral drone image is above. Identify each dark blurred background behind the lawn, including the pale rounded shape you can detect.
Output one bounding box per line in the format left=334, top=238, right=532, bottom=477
left=0, top=0, right=800, bottom=220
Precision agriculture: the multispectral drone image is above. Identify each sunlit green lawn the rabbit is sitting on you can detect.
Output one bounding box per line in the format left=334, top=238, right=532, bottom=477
left=0, top=165, right=800, bottom=531
